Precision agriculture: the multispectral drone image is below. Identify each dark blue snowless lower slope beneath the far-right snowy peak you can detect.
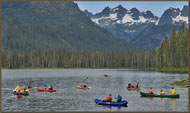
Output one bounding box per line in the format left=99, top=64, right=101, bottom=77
left=131, top=24, right=179, bottom=50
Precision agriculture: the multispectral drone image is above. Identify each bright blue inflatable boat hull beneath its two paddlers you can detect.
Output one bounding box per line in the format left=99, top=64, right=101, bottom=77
left=94, top=99, right=128, bottom=106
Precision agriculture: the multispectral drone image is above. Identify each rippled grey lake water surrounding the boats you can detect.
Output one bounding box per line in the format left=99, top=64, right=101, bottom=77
left=2, top=69, right=188, bottom=112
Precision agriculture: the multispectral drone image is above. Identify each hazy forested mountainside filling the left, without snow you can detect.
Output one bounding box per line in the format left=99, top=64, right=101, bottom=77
left=2, top=1, right=133, bottom=52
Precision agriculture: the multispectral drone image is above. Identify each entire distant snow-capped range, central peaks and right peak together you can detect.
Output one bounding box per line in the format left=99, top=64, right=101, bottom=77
left=86, top=5, right=188, bottom=50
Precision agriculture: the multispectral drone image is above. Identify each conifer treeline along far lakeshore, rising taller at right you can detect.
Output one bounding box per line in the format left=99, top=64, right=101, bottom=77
left=2, top=24, right=189, bottom=69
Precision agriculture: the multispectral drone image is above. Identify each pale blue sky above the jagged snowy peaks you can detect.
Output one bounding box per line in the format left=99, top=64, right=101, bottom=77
left=75, top=1, right=188, bottom=17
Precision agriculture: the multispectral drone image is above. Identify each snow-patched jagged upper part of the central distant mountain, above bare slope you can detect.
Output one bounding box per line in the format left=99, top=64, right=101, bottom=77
left=89, top=5, right=158, bottom=26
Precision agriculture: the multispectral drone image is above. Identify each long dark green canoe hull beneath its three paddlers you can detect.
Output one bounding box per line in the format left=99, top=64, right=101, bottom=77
left=140, top=92, right=179, bottom=98
